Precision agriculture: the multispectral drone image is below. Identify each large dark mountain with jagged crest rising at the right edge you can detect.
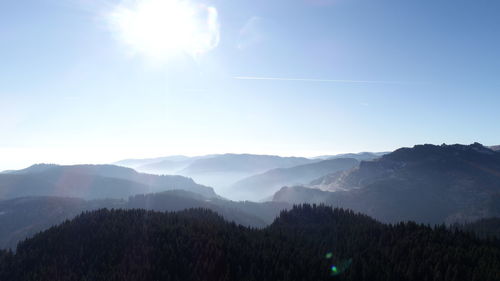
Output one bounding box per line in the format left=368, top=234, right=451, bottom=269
left=274, top=143, right=500, bottom=223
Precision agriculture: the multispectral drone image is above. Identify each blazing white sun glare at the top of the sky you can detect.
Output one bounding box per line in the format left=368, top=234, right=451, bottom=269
left=109, top=0, right=220, bottom=60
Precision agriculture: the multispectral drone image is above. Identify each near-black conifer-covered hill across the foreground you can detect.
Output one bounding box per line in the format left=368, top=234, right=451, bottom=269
left=0, top=205, right=500, bottom=281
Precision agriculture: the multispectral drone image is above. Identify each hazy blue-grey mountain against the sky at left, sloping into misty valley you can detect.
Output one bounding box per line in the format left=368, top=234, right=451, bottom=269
left=0, top=164, right=217, bottom=199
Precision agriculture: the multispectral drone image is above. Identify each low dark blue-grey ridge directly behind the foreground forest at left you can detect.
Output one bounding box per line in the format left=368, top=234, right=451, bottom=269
left=0, top=190, right=291, bottom=249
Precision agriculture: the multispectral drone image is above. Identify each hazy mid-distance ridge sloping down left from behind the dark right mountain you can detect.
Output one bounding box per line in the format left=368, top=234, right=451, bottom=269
left=231, top=158, right=359, bottom=200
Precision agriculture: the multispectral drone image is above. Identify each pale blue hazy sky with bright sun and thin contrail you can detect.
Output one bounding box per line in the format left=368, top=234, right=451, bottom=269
left=0, top=0, right=500, bottom=169
